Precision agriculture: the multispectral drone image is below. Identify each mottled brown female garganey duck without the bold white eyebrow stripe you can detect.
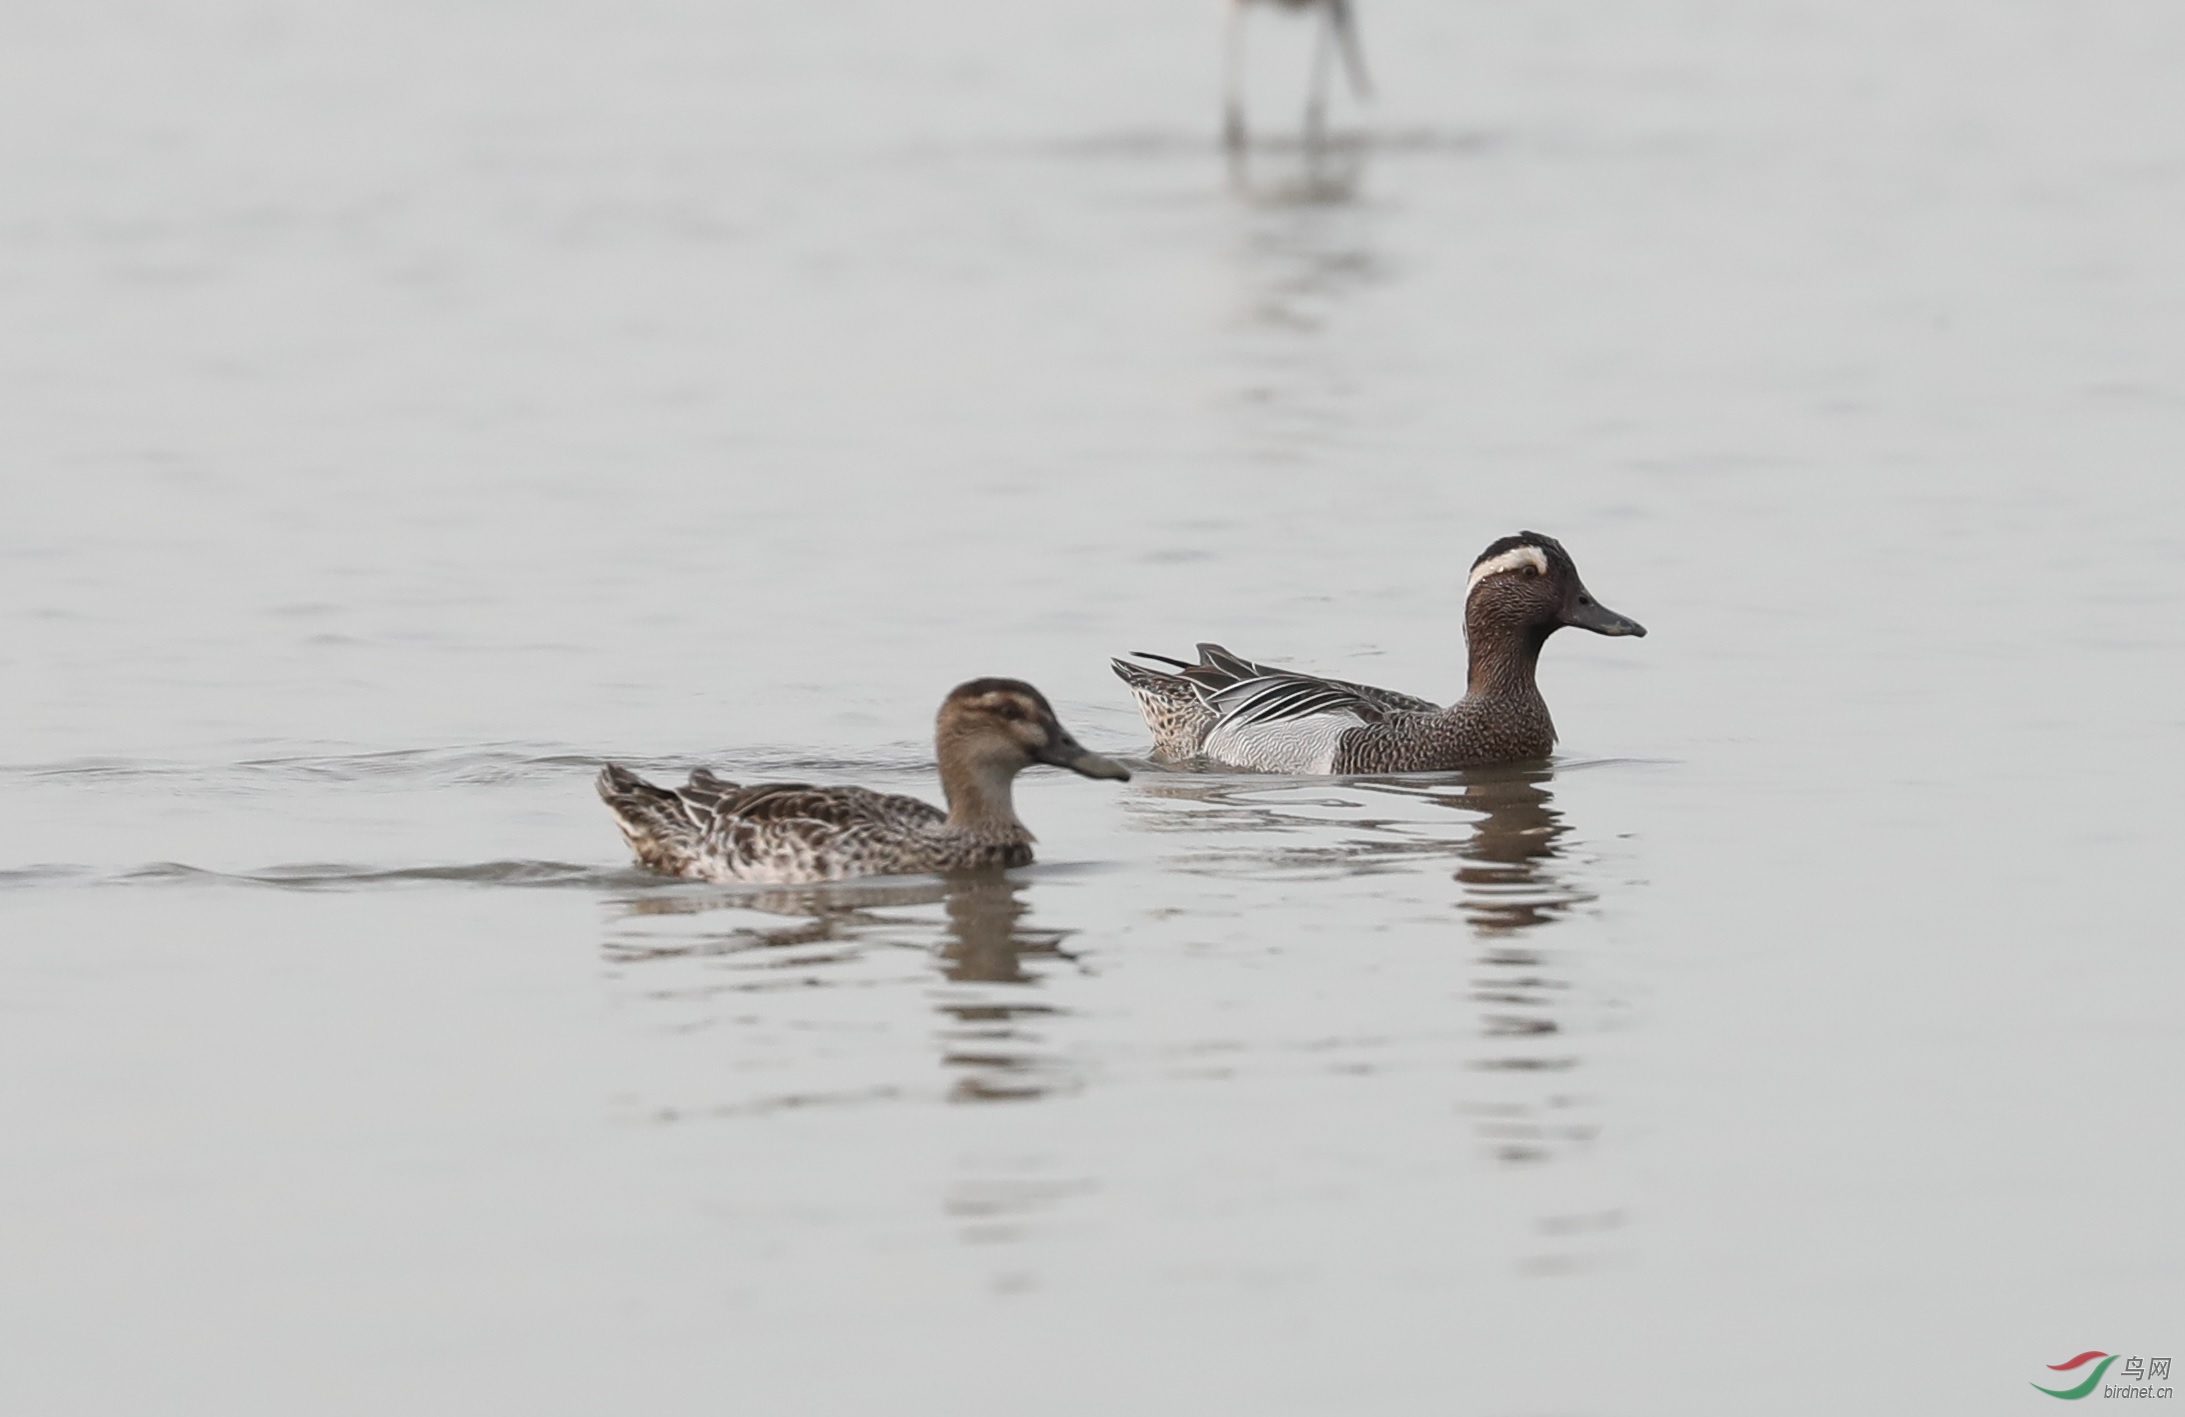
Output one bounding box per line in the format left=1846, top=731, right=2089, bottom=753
left=599, top=679, right=1130, bottom=884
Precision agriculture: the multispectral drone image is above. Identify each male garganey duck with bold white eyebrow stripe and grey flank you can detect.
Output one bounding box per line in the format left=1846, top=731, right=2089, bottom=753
left=1112, top=531, right=1645, bottom=773
